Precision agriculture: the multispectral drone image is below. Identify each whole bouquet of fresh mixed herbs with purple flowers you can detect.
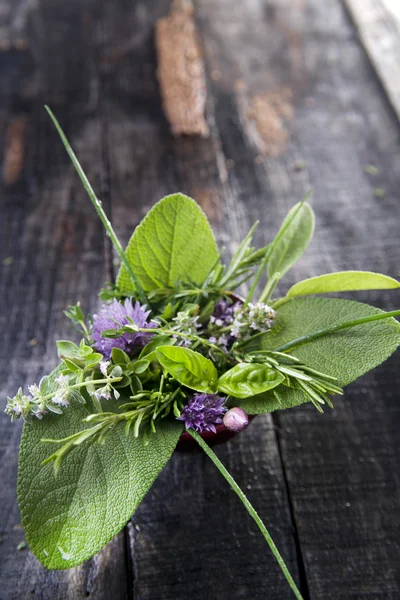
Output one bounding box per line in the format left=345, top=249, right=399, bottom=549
left=6, top=111, right=400, bottom=598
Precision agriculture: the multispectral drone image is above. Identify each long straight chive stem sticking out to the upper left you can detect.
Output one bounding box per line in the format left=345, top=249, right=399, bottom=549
left=45, top=106, right=148, bottom=304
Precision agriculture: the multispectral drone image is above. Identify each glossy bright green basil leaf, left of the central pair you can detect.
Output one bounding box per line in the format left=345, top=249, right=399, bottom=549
left=157, top=346, right=218, bottom=394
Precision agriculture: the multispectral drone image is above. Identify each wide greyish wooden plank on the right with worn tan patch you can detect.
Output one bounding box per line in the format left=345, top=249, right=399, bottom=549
left=192, top=0, right=400, bottom=599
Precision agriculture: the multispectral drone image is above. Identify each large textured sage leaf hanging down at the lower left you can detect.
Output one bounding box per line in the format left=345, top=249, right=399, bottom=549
left=18, top=378, right=182, bottom=569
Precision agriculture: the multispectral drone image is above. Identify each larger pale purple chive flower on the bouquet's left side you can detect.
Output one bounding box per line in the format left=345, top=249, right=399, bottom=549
left=92, top=298, right=157, bottom=359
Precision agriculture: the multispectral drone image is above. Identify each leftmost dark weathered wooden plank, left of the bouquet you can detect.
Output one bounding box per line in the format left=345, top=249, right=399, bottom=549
left=0, top=1, right=127, bottom=600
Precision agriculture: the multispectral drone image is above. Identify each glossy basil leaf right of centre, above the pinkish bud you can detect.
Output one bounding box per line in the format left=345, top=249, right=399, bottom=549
left=217, top=363, right=285, bottom=398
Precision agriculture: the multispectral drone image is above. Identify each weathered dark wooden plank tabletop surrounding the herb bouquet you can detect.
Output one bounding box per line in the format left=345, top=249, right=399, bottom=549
left=0, top=0, right=400, bottom=600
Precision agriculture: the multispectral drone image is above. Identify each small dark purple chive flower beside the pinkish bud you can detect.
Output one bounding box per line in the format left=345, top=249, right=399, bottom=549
left=178, top=394, right=227, bottom=433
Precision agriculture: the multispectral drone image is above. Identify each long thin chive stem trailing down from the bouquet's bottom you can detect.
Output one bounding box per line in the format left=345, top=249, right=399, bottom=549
left=188, top=429, right=303, bottom=600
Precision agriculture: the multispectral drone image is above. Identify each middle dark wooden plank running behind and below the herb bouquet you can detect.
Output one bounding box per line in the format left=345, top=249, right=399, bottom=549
left=101, top=0, right=304, bottom=600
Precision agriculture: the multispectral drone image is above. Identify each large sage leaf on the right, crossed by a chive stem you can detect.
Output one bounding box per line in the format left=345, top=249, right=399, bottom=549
left=236, top=298, right=400, bottom=414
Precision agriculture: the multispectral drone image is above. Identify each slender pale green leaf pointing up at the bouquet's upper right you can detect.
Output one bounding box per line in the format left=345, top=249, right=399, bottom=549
left=268, top=202, right=314, bottom=277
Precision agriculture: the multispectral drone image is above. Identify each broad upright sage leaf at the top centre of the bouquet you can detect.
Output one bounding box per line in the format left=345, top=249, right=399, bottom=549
left=117, top=194, right=218, bottom=292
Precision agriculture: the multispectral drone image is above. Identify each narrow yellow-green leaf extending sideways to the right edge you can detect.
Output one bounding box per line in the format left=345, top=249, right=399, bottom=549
left=287, top=271, right=400, bottom=298
